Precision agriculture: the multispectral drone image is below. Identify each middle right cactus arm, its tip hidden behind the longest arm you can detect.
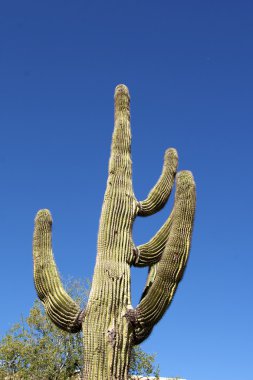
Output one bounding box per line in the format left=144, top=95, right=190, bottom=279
left=134, top=211, right=173, bottom=267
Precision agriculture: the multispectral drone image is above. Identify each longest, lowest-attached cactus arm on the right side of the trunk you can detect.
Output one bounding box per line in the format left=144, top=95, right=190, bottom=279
left=126, top=171, right=196, bottom=344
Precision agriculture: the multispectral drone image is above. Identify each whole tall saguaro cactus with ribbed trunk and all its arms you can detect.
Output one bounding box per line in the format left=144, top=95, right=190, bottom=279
left=33, top=85, right=195, bottom=380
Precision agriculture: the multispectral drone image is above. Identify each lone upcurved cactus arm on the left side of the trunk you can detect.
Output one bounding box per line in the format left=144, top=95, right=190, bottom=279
left=33, top=210, right=84, bottom=333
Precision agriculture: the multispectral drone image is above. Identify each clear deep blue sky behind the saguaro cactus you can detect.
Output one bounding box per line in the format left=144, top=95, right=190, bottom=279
left=0, top=0, right=253, bottom=380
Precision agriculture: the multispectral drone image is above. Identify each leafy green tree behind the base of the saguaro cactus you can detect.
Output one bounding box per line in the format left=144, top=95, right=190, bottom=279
left=0, top=281, right=156, bottom=380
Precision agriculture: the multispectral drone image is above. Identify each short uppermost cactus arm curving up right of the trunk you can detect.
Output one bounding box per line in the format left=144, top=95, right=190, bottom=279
left=138, top=148, right=178, bottom=216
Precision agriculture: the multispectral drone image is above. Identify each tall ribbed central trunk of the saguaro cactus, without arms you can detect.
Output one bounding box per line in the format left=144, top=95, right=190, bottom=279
left=83, top=84, right=136, bottom=380
